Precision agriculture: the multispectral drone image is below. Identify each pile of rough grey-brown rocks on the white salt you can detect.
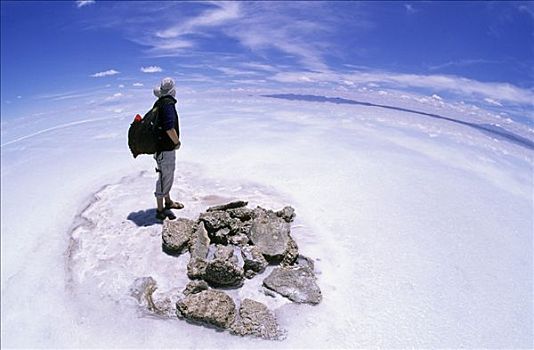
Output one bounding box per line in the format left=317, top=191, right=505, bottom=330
left=141, top=201, right=322, bottom=339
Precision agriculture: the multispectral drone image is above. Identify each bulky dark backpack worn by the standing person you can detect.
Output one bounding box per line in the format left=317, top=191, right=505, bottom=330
left=128, top=106, right=159, bottom=158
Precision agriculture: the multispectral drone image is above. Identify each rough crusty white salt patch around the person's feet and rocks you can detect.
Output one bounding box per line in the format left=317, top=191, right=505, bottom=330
left=66, top=164, right=306, bottom=326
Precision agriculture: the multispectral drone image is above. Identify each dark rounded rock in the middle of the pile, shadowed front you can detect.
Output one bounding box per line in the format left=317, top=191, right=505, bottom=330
left=203, top=259, right=245, bottom=287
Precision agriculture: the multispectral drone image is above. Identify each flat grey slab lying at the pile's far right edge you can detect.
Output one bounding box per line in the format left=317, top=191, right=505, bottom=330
left=263, top=267, right=322, bottom=304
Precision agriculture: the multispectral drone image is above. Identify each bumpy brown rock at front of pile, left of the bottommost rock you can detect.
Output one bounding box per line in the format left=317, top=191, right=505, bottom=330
left=176, top=289, right=236, bottom=328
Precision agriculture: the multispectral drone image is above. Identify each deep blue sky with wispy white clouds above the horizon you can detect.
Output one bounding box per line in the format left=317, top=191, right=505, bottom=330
left=1, top=1, right=534, bottom=119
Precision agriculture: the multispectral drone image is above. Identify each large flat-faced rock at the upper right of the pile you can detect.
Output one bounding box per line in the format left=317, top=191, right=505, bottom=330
left=249, top=207, right=290, bottom=261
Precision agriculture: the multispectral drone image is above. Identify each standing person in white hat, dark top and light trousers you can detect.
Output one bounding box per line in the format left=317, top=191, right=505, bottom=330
left=154, top=78, right=184, bottom=220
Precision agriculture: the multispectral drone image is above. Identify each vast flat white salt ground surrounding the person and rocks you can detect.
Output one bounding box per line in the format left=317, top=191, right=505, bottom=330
left=1, top=90, right=533, bottom=348
